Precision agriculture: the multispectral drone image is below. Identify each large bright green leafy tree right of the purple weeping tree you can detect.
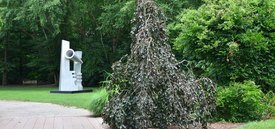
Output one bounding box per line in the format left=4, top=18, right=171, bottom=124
left=170, top=0, right=275, bottom=91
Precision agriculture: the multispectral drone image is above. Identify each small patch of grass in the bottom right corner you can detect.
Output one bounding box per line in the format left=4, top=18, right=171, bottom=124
left=238, top=119, right=275, bottom=129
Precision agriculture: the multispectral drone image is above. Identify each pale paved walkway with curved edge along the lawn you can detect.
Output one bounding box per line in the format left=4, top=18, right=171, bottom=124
left=0, top=101, right=108, bottom=129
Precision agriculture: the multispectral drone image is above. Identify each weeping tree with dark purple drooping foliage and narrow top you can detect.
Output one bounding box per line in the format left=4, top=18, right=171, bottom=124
left=103, top=0, right=215, bottom=129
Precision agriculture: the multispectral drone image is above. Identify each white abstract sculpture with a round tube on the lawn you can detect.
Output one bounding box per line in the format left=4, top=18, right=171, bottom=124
left=59, top=40, right=83, bottom=92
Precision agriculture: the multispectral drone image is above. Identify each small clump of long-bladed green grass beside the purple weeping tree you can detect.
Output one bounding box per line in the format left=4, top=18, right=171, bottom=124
left=90, top=88, right=108, bottom=116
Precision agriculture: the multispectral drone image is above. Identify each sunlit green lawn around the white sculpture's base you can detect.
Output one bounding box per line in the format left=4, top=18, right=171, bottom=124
left=0, top=86, right=96, bottom=109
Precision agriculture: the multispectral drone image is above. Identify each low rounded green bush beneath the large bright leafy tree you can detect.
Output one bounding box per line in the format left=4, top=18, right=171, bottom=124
left=217, top=81, right=267, bottom=122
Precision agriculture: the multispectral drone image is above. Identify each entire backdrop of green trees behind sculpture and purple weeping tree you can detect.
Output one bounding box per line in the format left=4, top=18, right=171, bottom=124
left=0, top=0, right=275, bottom=91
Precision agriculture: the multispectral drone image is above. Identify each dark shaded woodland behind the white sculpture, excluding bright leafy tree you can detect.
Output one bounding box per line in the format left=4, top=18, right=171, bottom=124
left=0, top=0, right=203, bottom=85
